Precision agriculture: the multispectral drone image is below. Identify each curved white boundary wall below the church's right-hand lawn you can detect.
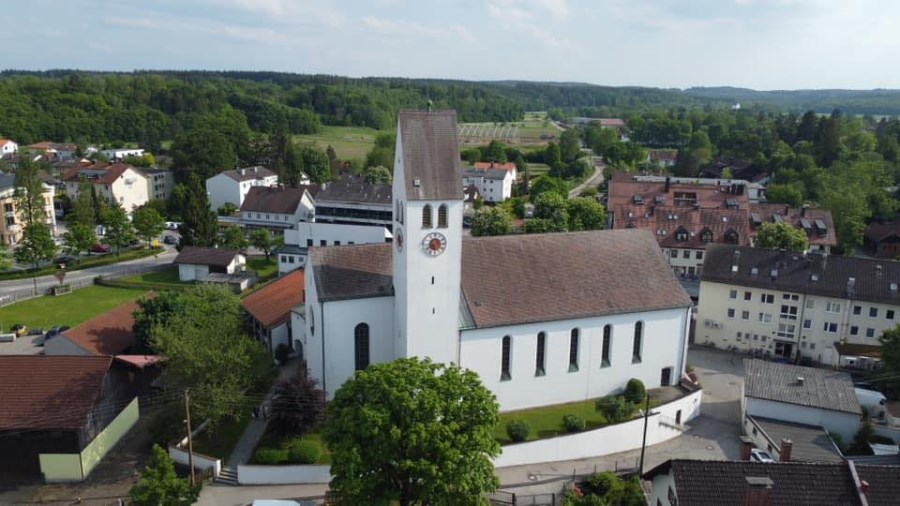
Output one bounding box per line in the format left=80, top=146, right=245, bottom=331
left=494, top=390, right=703, bottom=467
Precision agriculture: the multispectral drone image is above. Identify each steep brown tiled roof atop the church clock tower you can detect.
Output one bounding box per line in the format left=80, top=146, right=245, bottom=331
left=398, top=110, right=463, bottom=201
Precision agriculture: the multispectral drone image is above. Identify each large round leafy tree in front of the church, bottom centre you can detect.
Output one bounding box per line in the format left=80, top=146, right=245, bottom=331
left=323, top=358, right=500, bottom=506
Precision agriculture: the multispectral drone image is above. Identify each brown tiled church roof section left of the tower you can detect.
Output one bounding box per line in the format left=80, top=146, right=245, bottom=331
left=308, top=243, right=394, bottom=301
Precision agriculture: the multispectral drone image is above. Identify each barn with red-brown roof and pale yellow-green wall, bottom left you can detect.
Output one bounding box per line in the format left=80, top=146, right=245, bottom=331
left=0, top=355, right=139, bottom=482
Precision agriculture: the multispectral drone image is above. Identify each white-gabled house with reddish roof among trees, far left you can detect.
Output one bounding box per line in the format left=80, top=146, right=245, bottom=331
left=62, top=163, right=150, bottom=215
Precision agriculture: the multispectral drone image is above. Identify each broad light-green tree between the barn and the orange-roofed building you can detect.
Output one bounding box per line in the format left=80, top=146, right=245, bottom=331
left=150, top=285, right=273, bottom=427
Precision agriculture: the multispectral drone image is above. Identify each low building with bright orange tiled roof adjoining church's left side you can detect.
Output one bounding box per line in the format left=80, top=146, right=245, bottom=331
left=241, top=269, right=305, bottom=359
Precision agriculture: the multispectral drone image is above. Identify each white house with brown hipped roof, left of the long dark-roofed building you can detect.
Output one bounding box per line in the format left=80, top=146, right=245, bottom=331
left=237, top=186, right=318, bottom=234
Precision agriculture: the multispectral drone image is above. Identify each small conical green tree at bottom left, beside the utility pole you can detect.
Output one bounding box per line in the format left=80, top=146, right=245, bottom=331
left=129, top=445, right=201, bottom=506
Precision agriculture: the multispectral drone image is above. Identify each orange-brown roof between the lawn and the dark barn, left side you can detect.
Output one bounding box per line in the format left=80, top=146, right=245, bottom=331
left=63, top=293, right=150, bottom=355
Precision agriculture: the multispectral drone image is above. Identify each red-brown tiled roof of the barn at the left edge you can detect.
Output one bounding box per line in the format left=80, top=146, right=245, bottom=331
left=0, top=355, right=112, bottom=431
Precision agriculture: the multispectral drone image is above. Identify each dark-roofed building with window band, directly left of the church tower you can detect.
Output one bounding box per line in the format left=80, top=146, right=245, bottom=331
left=314, top=176, right=393, bottom=228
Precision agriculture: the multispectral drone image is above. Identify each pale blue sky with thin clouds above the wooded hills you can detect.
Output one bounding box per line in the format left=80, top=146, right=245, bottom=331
left=7, top=0, right=900, bottom=90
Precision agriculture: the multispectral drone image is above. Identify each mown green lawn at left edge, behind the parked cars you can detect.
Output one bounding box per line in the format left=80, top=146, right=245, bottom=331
left=0, top=286, right=146, bottom=330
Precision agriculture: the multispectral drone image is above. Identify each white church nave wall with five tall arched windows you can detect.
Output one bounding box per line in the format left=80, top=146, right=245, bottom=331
left=460, top=308, right=687, bottom=411
